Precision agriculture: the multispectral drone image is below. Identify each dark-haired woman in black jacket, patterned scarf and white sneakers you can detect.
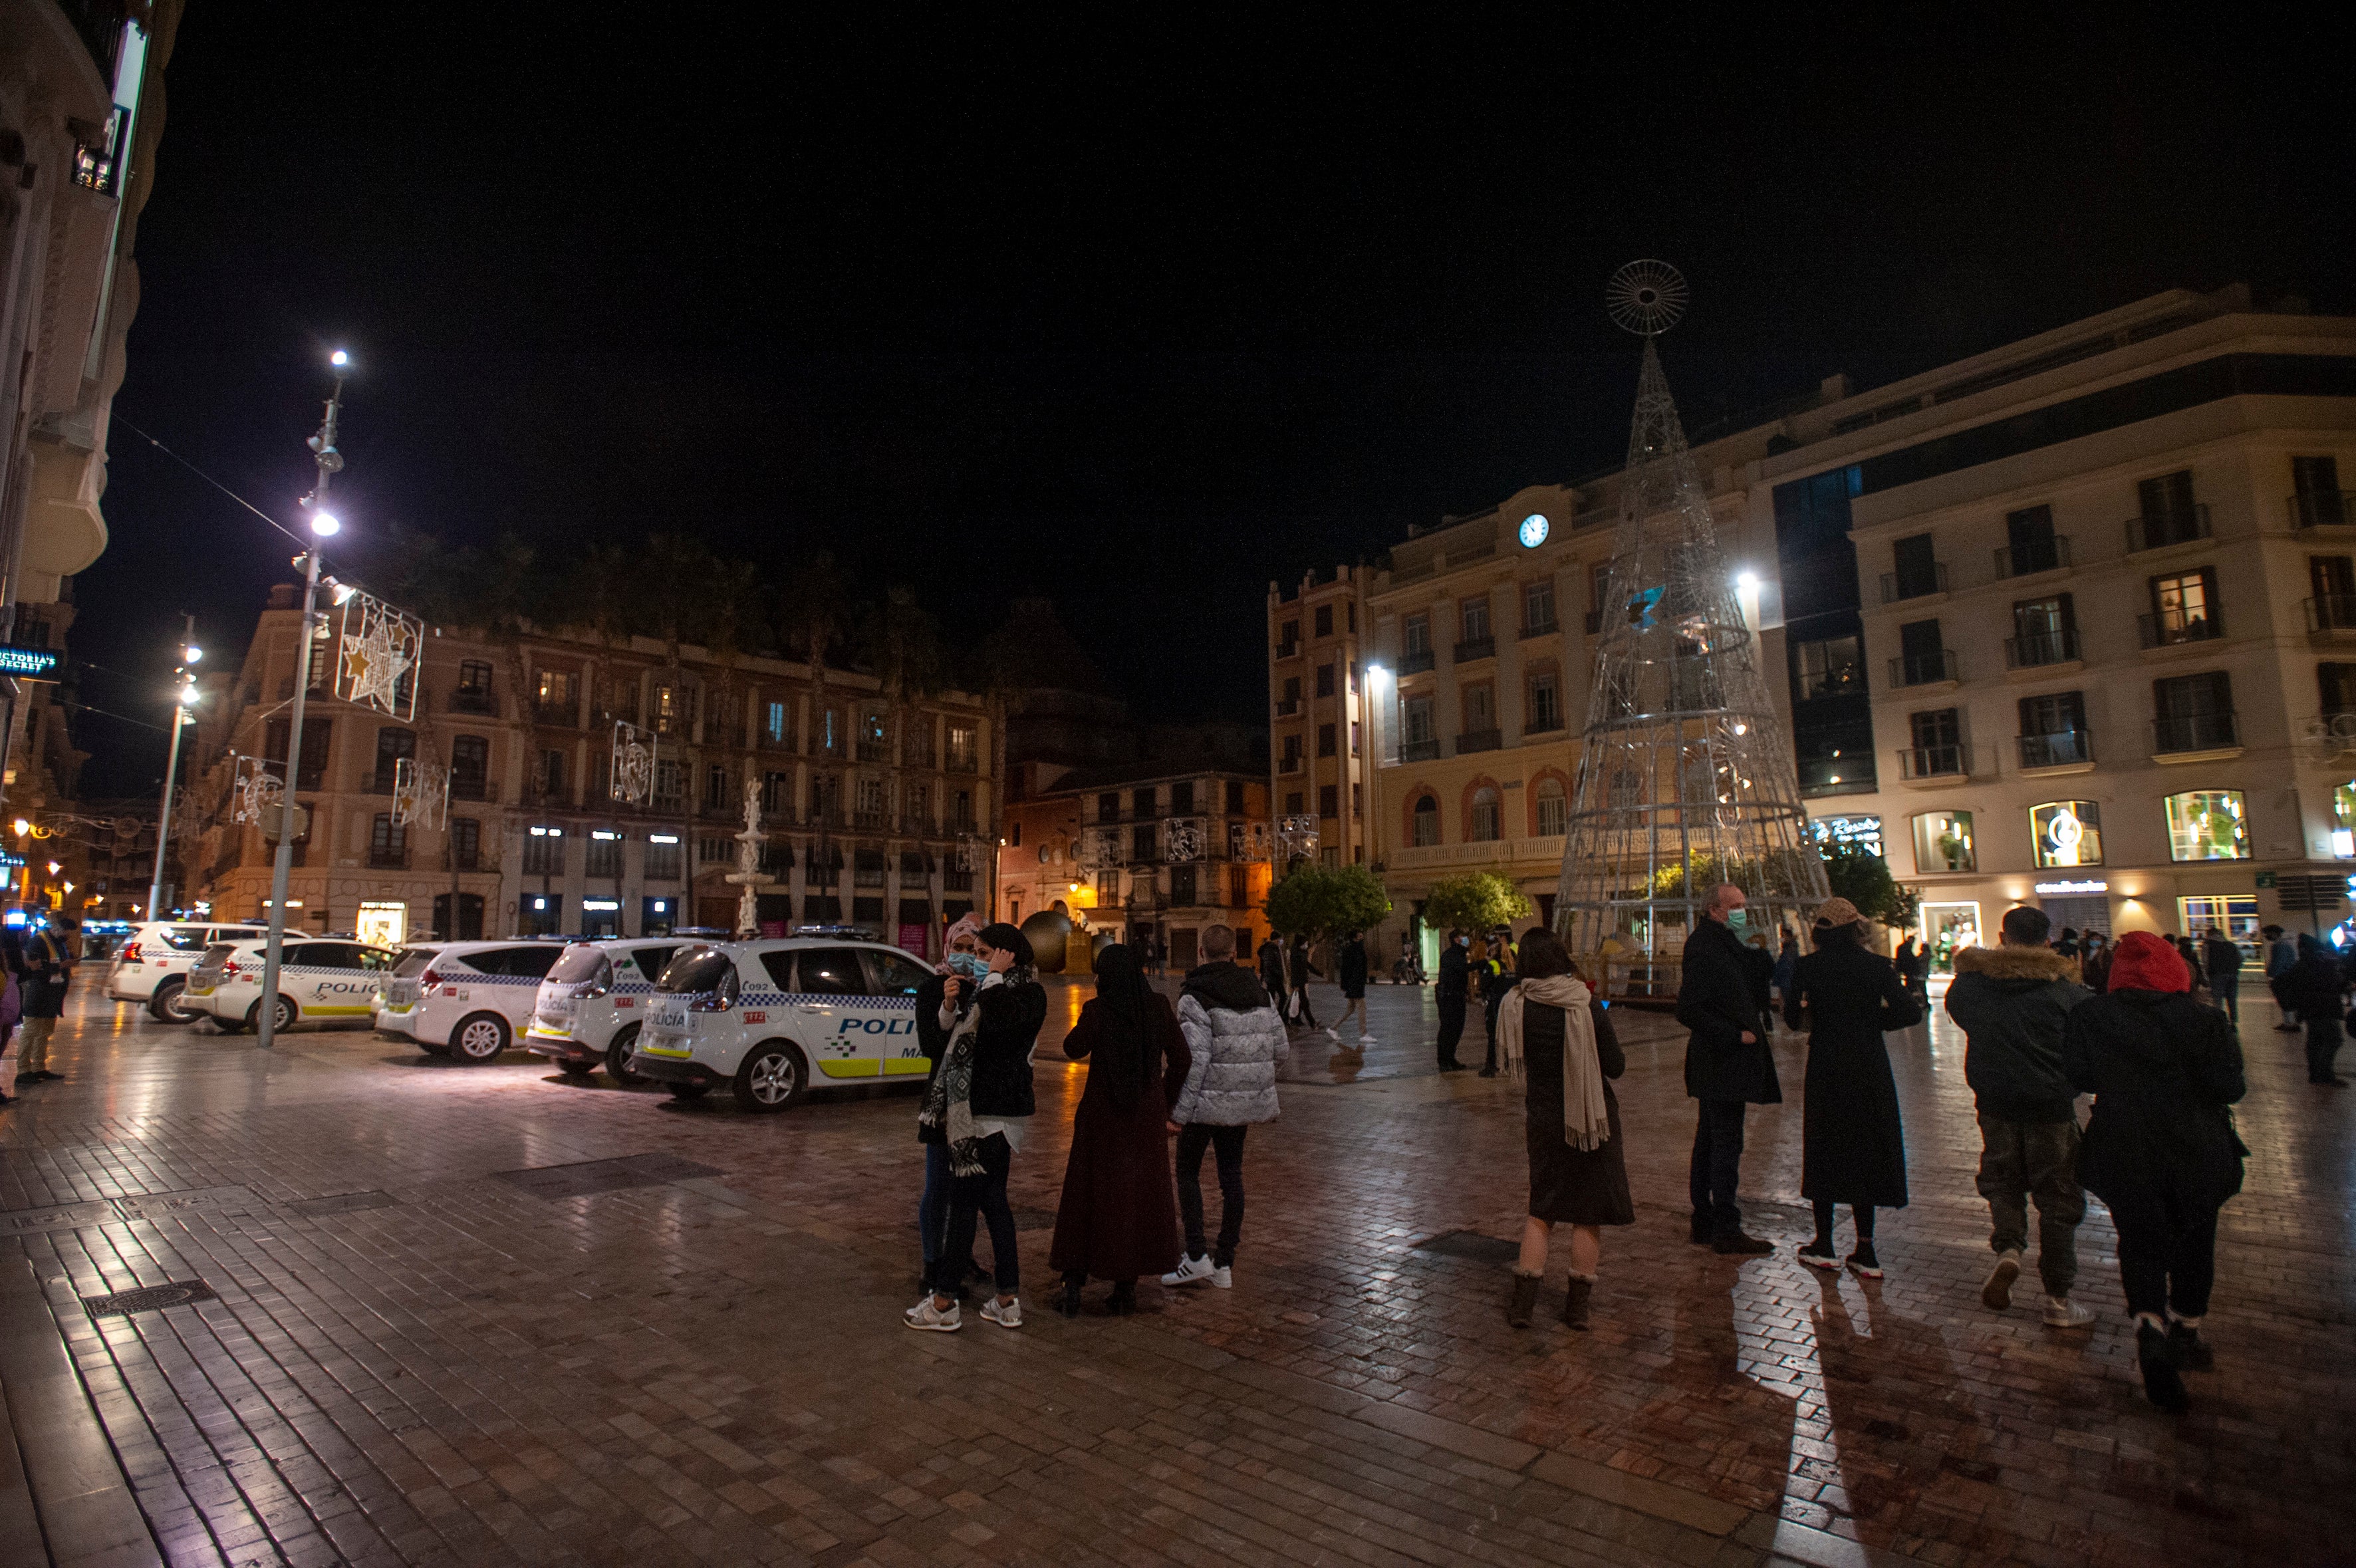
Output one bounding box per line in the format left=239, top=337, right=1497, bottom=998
left=905, top=920, right=1046, bottom=1333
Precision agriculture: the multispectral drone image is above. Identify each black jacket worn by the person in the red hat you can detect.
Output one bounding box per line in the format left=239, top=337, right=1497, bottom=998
left=2061, top=991, right=2248, bottom=1212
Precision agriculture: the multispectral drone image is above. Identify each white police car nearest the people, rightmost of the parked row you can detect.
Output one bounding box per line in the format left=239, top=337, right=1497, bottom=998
left=629, top=937, right=933, bottom=1111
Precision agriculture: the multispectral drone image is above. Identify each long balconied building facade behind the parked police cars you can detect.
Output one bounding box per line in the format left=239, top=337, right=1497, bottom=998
left=174, top=587, right=999, bottom=956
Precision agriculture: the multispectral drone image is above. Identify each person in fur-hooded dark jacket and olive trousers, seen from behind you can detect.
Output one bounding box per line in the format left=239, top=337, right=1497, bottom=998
left=1946, top=904, right=2095, bottom=1328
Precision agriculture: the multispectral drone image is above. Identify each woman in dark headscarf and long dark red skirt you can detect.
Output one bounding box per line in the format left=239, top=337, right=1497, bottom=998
left=1046, top=944, right=1192, bottom=1319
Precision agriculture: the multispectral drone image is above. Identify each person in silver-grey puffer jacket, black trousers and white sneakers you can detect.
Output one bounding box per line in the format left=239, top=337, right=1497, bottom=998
left=1162, top=925, right=1291, bottom=1290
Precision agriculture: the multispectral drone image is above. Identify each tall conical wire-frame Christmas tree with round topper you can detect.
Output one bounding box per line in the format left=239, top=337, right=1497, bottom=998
left=1555, top=261, right=1828, bottom=996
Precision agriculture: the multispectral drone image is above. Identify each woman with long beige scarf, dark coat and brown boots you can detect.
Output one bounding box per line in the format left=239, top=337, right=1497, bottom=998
left=1496, top=925, right=1635, bottom=1330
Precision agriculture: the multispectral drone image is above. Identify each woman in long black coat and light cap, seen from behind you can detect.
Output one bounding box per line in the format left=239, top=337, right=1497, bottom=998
left=1783, top=899, right=1922, bottom=1279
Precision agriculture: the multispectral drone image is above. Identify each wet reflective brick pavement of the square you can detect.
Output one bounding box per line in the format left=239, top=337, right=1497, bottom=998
left=0, top=970, right=2356, bottom=1565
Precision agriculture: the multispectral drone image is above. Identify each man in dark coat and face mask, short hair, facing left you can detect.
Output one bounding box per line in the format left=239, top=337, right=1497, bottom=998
left=1678, top=883, right=1783, bottom=1255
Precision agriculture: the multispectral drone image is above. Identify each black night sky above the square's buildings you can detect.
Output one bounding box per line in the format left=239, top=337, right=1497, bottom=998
left=73, top=12, right=2356, bottom=793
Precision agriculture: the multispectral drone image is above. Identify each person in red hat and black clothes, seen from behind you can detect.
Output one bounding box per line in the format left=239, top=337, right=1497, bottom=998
left=2061, top=930, right=2250, bottom=1410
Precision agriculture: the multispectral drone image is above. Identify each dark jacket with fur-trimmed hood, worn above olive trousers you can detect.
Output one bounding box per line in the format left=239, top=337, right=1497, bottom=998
left=1946, top=946, right=2090, bottom=1123
